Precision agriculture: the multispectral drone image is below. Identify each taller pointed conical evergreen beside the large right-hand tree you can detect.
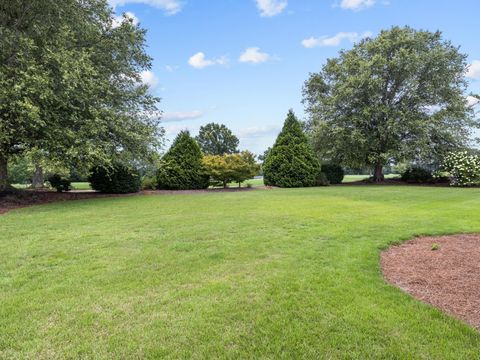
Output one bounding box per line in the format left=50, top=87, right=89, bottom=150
left=263, top=110, right=320, bottom=187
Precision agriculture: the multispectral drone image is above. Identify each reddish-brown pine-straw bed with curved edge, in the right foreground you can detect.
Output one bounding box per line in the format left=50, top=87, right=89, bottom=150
left=381, top=234, right=480, bottom=329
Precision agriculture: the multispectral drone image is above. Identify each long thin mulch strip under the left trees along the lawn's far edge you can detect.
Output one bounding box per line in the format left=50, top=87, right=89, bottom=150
left=0, top=187, right=261, bottom=215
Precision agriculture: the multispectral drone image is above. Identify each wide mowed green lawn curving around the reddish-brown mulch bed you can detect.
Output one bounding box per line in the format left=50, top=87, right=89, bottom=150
left=0, top=186, right=480, bottom=359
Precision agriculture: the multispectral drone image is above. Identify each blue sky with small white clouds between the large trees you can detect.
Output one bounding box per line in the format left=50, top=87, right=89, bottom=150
left=109, top=0, right=480, bottom=154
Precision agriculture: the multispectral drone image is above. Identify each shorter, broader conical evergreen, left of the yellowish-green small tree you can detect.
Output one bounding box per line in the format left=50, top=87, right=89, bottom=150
left=157, top=131, right=209, bottom=190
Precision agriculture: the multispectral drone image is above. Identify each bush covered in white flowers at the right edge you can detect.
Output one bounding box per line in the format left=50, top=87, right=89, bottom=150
left=443, top=151, right=480, bottom=186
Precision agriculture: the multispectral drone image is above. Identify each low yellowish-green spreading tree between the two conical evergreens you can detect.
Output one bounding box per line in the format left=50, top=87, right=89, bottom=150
left=203, top=151, right=260, bottom=187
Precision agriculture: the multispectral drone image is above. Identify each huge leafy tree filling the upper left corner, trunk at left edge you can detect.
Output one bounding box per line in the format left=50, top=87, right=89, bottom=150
left=0, top=0, right=161, bottom=191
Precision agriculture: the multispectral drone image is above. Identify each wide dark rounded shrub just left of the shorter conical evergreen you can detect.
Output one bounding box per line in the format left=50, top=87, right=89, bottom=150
left=88, top=164, right=141, bottom=194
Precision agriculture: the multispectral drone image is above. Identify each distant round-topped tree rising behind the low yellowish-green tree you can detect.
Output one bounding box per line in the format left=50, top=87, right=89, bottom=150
left=196, top=123, right=239, bottom=155
